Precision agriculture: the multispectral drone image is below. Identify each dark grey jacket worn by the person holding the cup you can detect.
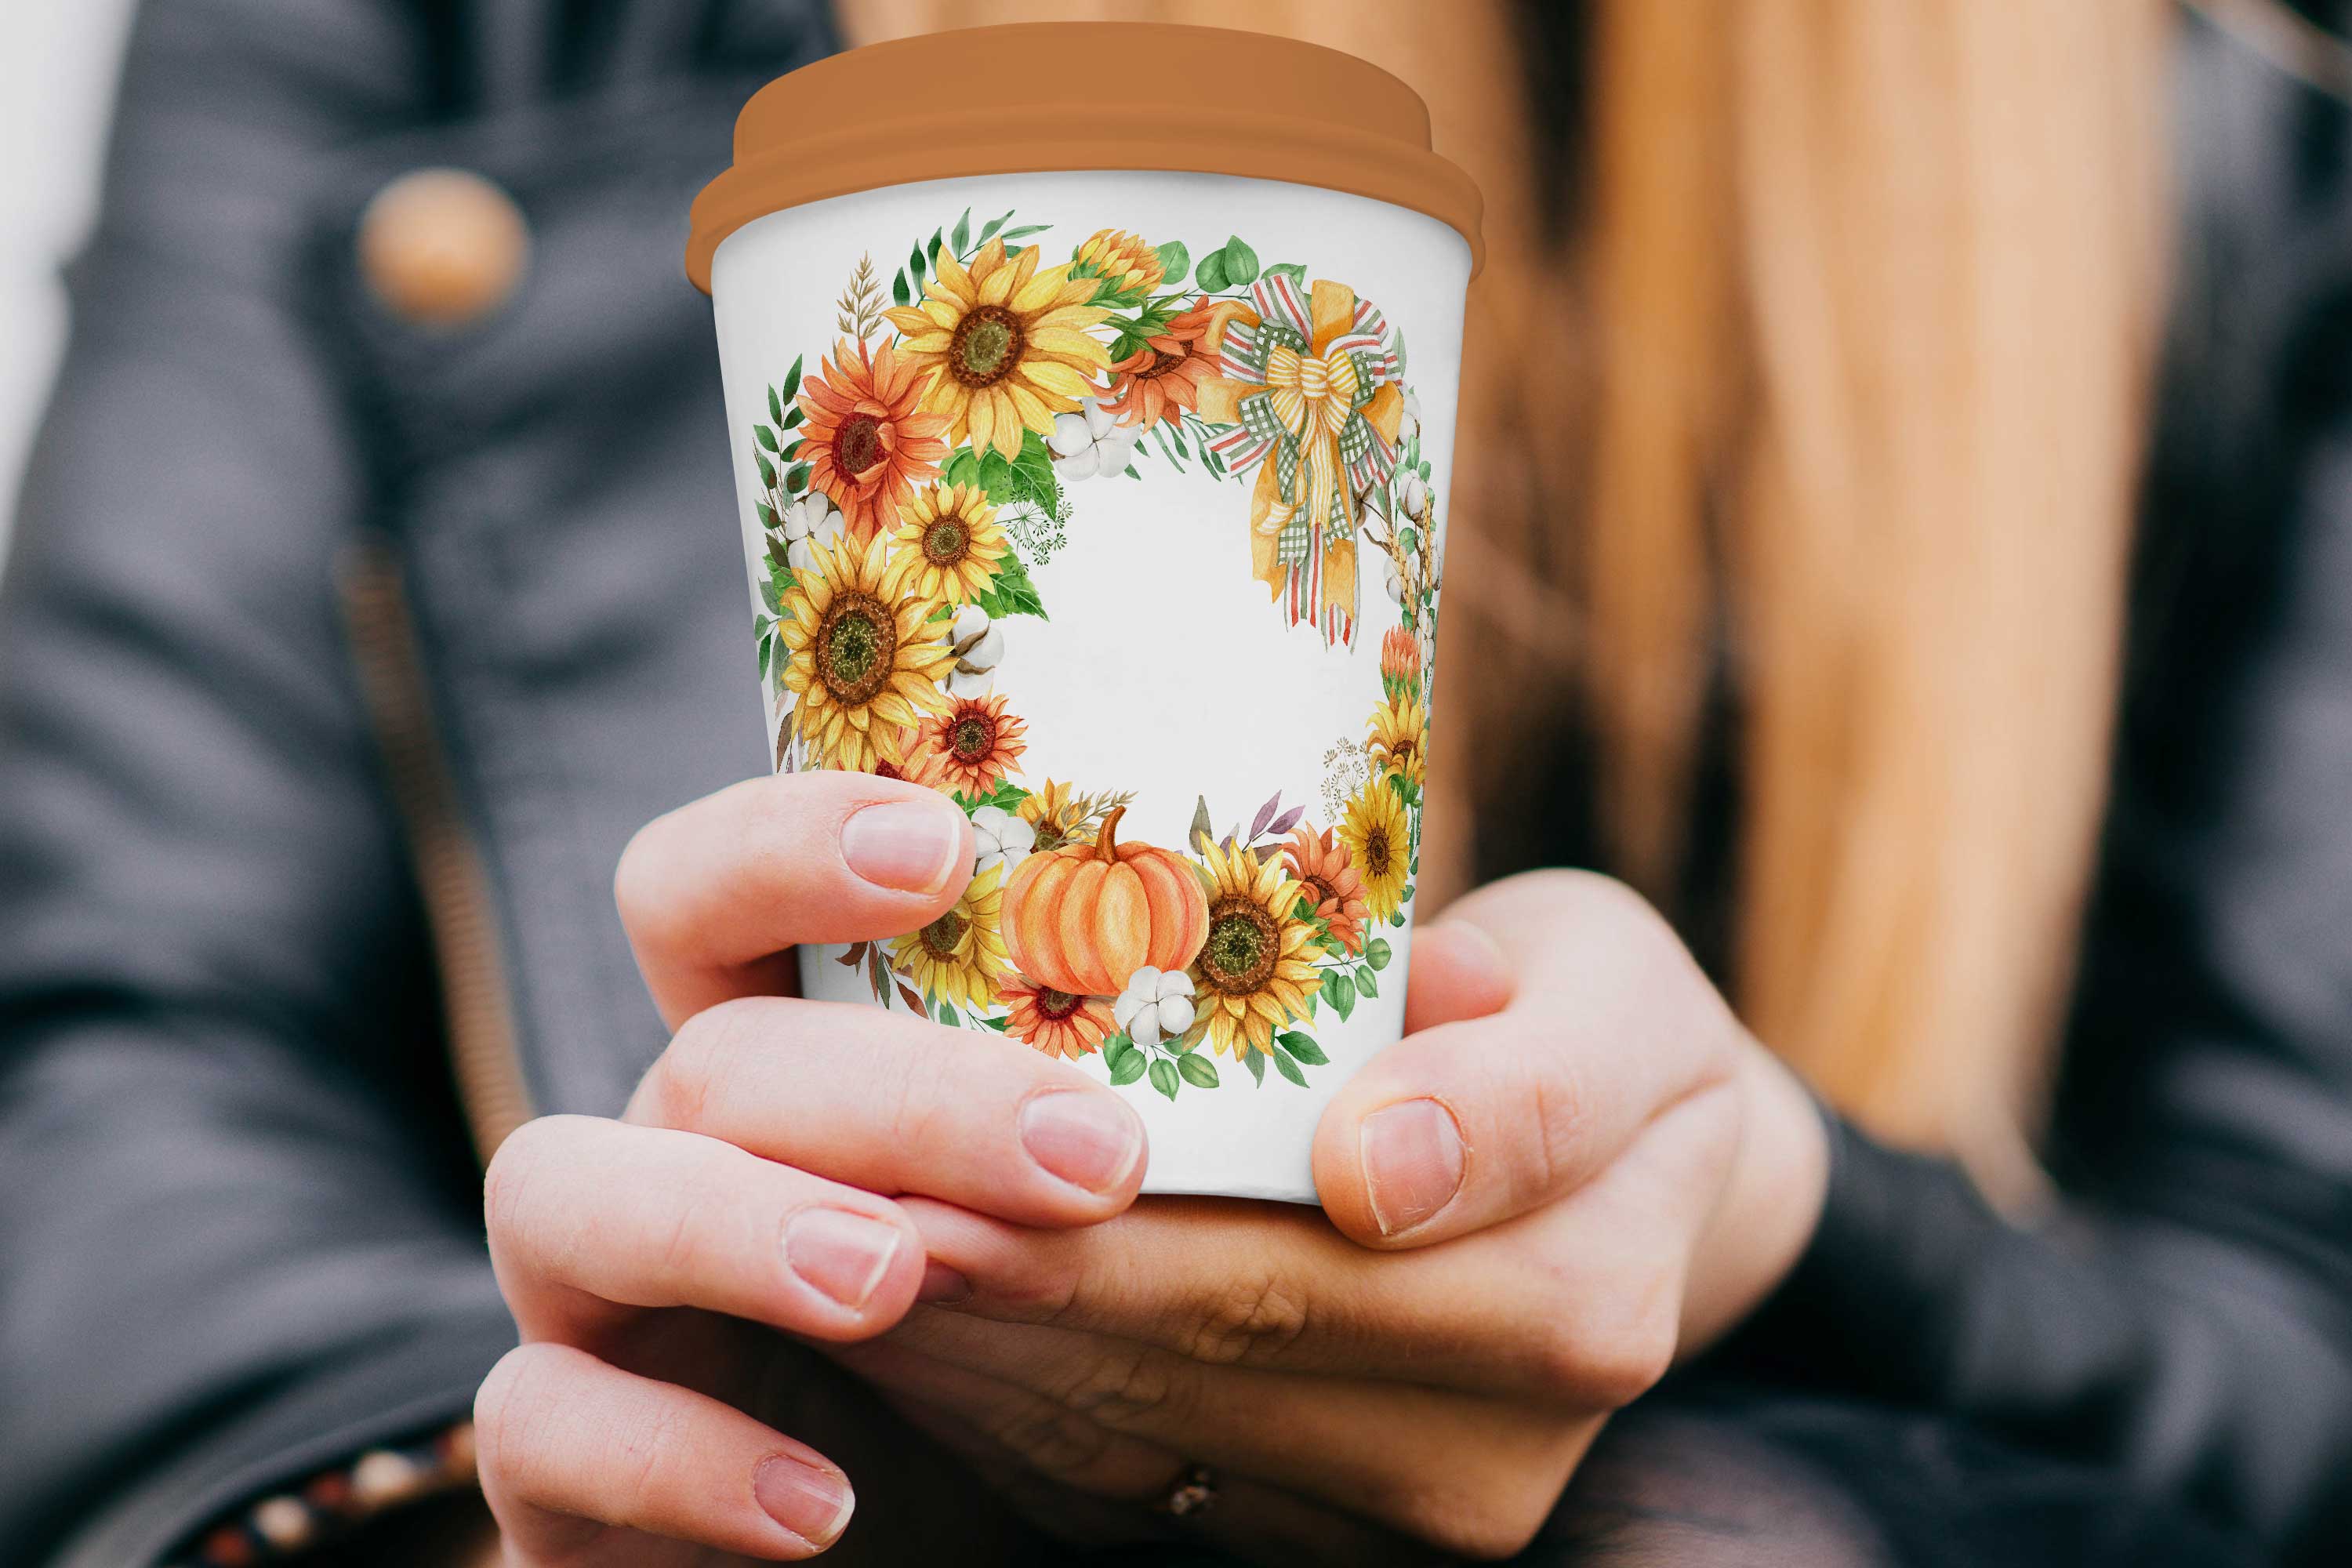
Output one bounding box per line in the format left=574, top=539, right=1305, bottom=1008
left=0, top=0, right=2352, bottom=1568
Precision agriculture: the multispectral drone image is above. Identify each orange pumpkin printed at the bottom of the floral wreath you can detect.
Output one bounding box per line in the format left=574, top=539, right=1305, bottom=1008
left=1004, top=806, right=1209, bottom=996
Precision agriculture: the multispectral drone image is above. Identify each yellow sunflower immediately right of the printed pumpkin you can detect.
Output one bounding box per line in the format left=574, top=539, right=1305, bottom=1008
left=1192, top=841, right=1315, bottom=1060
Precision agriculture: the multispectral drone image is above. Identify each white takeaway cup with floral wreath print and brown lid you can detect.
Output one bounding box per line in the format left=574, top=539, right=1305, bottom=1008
left=687, top=24, right=1479, bottom=1201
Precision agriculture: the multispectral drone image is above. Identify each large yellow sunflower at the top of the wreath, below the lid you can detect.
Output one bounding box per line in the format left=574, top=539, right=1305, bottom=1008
left=884, top=240, right=1110, bottom=459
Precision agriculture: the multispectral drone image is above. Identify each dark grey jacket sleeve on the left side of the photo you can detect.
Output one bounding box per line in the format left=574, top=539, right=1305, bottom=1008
left=0, top=0, right=513, bottom=1568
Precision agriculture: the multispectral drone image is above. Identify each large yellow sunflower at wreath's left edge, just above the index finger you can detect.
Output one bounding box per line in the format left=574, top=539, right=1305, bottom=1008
left=779, top=534, right=955, bottom=774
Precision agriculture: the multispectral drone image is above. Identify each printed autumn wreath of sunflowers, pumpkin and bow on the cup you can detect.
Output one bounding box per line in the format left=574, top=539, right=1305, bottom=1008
left=753, top=212, right=1437, bottom=1100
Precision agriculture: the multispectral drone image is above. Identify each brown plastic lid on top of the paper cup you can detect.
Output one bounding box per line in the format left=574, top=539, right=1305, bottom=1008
left=687, top=21, right=1486, bottom=294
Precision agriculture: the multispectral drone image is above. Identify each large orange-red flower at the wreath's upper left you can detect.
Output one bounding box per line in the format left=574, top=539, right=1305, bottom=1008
left=800, top=339, right=948, bottom=543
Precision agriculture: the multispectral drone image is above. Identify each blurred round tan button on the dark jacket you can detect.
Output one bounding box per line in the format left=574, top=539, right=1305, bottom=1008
left=360, top=169, right=532, bottom=327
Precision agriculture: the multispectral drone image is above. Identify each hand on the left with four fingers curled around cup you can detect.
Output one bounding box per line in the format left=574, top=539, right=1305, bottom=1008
left=475, top=774, right=1145, bottom=1568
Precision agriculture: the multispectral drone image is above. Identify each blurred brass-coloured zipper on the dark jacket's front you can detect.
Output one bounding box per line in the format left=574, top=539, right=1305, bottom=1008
left=339, top=543, right=534, bottom=1166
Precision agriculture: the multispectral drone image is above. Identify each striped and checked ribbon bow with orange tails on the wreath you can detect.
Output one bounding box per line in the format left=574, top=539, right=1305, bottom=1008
left=1200, top=273, right=1404, bottom=642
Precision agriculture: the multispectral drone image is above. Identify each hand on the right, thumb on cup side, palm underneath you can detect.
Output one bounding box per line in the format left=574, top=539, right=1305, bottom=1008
left=833, top=872, right=1828, bottom=1563
